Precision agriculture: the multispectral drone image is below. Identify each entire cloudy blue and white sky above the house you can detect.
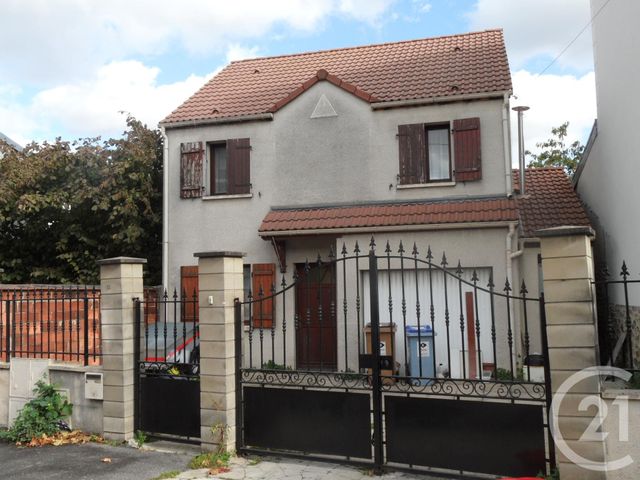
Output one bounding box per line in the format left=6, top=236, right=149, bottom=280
left=0, top=0, right=596, bottom=162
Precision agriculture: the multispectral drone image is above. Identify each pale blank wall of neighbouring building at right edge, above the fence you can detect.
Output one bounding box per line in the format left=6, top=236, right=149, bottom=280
left=578, top=0, right=640, bottom=284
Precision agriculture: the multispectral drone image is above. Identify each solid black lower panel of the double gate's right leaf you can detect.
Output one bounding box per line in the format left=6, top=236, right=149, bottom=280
left=385, top=396, right=546, bottom=477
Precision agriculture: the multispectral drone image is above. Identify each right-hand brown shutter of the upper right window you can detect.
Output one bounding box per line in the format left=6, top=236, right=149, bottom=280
left=453, top=117, right=482, bottom=182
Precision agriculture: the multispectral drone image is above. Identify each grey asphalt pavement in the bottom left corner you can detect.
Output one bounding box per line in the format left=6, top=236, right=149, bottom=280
left=0, top=443, right=193, bottom=480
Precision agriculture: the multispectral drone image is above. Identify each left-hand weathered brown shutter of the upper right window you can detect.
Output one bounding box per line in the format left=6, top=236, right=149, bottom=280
left=398, top=123, right=427, bottom=185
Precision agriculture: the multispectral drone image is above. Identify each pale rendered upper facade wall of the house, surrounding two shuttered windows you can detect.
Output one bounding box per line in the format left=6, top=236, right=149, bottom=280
left=167, top=82, right=507, bottom=287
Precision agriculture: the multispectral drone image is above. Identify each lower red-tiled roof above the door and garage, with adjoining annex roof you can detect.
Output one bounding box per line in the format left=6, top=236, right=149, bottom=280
left=259, top=168, right=590, bottom=237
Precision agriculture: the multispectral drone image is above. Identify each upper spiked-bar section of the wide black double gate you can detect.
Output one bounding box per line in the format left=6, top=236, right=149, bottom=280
left=242, top=243, right=546, bottom=390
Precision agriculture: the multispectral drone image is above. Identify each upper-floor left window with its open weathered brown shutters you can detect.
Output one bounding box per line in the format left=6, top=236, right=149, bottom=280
left=180, top=138, right=251, bottom=198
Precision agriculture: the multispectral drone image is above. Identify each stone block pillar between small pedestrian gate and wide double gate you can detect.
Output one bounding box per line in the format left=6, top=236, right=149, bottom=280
left=195, top=252, right=244, bottom=450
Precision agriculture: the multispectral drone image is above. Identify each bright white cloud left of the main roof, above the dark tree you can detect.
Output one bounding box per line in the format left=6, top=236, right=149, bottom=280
left=0, top=60, right=213, bottom=143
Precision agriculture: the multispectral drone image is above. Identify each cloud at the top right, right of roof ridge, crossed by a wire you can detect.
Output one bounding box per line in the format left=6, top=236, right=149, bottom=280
left=468, top=0, right=593, bottom=71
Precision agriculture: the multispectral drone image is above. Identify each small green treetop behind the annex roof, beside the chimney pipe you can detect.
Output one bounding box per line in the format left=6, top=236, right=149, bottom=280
left=525, top=122, right=584, bottom=175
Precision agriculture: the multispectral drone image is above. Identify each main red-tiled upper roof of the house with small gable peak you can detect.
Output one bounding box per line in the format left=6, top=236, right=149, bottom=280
left=161, top=30, right=511, bottom=124
